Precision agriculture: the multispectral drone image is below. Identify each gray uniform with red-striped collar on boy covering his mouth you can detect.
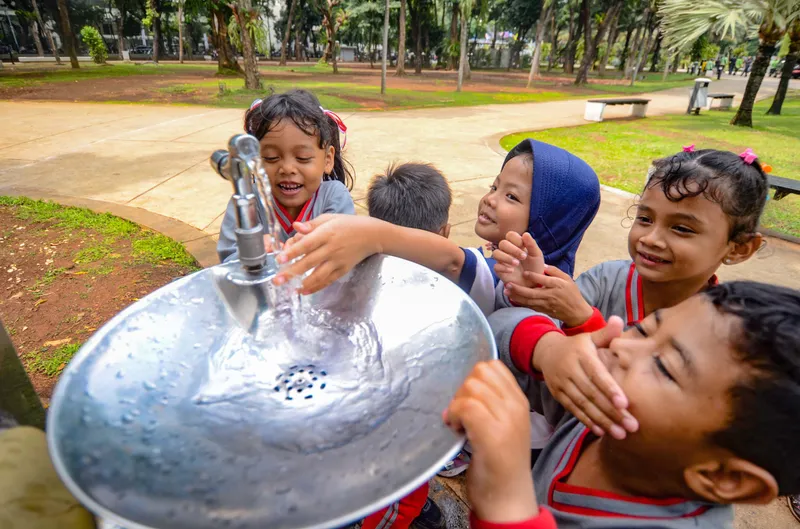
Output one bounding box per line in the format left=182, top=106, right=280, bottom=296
left=489, top=308, right=733, bottom=529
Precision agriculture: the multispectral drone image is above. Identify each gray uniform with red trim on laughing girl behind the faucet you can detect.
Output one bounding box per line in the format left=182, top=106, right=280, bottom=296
left=217, top=180, right=356, bottom=263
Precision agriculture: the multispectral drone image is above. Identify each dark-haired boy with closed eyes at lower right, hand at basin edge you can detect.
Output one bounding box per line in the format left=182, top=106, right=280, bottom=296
left=444, top=281, right=800, bottom=529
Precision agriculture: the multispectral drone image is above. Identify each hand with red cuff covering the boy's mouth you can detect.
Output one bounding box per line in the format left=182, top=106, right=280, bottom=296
left=533, top=316, right=639, bottom=439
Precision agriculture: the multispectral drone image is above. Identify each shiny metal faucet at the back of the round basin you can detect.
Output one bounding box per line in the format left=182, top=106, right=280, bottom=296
left=210, top=134, right=280, bottom=274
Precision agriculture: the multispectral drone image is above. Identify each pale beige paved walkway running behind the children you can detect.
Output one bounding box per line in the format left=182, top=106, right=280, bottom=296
left=0, top=78, right=800, bottom=529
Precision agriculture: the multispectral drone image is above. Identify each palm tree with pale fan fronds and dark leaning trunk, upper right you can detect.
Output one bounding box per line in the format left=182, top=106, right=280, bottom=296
left=659, top=0, right=800, bottom=127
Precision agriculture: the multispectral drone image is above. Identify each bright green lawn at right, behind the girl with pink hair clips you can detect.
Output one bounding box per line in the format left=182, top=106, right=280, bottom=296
left=500, top=91, right=800, bottom=237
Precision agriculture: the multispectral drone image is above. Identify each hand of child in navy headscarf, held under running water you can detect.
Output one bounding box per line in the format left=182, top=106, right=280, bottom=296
left=273, top=215, right=381, bottom=294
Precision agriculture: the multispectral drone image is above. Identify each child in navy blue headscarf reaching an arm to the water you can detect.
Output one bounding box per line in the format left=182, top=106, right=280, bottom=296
left=276, top=140, right=600, bottom=314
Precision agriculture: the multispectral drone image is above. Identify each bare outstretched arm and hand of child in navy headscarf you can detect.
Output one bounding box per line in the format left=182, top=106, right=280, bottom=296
left=275, top=215, right=464, bottom=294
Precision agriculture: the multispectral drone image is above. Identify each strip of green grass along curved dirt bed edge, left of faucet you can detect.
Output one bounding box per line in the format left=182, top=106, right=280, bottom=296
left=0, top=196, right=198, bottom=268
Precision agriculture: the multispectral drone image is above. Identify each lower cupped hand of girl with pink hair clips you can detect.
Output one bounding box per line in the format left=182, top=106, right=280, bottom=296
left=501, top=266, right=592, bottom=327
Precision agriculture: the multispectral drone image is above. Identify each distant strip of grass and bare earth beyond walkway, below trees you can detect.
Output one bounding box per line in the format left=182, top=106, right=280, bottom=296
left=0, top=62, right=691, bottom=110
